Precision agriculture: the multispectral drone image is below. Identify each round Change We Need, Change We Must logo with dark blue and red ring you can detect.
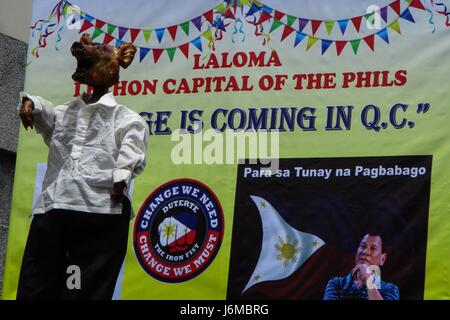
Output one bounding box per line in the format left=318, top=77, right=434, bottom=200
left=133, top=179, right=224, bottom=283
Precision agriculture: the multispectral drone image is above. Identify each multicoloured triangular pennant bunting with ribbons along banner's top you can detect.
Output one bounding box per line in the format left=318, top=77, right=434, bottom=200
left=31, top=0, right=425, bottom=63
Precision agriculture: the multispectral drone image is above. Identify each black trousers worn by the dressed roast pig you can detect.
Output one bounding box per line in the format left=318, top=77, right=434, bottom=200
left=17, top=199, right=130, bottom=300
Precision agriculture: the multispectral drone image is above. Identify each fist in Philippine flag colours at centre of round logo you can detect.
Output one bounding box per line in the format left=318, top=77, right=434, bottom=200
left=158, top=212, right=196, bottom=253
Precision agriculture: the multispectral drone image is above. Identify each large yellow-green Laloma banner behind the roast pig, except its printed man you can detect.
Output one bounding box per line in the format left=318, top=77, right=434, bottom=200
left=3, top=0, right=450, bottom=299
